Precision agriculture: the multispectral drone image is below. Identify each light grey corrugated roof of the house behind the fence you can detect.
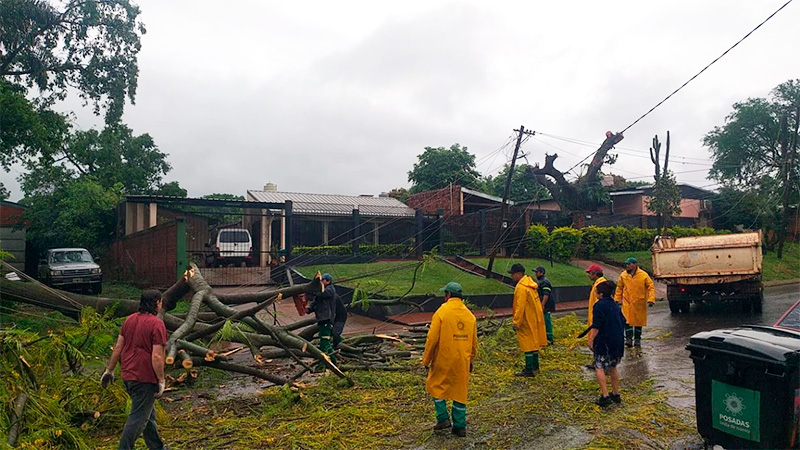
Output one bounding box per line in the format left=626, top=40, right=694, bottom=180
left=247, top=191, right=415, bottom=217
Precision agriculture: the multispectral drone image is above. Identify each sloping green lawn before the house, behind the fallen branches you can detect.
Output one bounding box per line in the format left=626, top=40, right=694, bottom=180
left=298, top=261, right=513, bottom=296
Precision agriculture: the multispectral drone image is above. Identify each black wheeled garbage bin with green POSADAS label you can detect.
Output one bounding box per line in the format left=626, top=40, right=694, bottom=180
left=686, top=326, right=800, bottom=448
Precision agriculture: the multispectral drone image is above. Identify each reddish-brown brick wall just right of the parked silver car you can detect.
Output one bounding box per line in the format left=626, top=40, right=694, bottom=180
left=105, top=222, right=177, bottom=288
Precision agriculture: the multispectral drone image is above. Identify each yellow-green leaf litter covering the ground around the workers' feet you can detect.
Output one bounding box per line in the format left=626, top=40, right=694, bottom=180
left=86, top=315, right=696, bottom=449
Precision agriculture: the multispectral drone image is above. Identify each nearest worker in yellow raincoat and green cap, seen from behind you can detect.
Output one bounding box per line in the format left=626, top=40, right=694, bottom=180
left=422, top=281, right=478, bottom=437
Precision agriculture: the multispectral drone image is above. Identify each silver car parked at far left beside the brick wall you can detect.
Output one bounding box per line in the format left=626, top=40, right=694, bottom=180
left=38, top=248, right=103, bottom=294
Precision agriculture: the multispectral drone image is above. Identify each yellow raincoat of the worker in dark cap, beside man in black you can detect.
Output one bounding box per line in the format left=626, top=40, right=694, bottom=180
left=513, top=275, right=547, bottom=352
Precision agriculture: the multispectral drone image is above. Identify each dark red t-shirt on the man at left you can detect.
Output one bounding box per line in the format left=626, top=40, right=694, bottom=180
left=119, top=312, right=167, bottom=384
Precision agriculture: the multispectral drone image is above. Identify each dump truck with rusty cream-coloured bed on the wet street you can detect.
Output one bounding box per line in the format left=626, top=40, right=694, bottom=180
left=652, top=231, right=764, bottom=313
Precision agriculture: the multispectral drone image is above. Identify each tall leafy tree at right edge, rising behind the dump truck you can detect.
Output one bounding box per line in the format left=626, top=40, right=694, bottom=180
left=703, top=79, right=800, bottom=243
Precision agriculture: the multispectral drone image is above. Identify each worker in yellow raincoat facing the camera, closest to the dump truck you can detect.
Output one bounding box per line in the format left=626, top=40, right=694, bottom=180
left=614, top=258, right=656, bottom=348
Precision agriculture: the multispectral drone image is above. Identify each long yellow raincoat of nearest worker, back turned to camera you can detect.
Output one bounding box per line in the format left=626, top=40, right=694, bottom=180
left=422, top=297, right=478, bottom=403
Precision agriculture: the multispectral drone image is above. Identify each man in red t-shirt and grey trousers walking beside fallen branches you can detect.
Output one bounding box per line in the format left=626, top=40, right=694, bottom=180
left=101, top=290, right=167, bottom=450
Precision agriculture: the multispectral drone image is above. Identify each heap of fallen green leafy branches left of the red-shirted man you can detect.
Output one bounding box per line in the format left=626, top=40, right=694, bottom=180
left=0, top=308, right=128, bottom=450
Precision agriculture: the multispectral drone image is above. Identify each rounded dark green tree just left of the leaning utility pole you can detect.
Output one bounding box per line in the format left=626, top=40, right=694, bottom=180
left=408, top=144, right=481, bottom=194
